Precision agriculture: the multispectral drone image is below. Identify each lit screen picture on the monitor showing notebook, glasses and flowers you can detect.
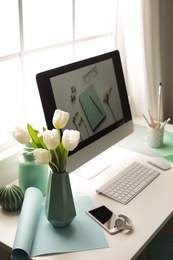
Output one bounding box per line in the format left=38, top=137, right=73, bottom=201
left=50, top=59, right=123, bottom=141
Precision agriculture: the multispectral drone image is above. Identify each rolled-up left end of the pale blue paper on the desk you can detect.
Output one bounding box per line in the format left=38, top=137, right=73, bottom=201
left=12, top=187, right=43, bottom=260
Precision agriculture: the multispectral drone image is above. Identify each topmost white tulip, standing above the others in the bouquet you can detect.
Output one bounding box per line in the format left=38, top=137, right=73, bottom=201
left=52, top=109, right=70, bottom=129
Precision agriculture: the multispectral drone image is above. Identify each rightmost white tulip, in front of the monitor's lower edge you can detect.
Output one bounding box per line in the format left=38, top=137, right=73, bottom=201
left=62, top=129, right=80, bottom=151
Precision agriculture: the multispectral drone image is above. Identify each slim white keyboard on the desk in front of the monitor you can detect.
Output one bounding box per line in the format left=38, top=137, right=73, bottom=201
left=96, top=162, right=160, bottom=204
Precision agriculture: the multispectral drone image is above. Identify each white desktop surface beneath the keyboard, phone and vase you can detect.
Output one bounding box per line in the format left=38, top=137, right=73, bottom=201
left=0, top=118, right=173, bottom=260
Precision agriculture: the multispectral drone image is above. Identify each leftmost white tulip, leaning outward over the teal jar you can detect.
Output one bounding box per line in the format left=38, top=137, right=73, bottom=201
left=11, top=127, right=30, bottom=144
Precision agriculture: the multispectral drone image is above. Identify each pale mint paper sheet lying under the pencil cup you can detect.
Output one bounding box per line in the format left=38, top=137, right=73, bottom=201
left=117, top=124, right=173, bottom=162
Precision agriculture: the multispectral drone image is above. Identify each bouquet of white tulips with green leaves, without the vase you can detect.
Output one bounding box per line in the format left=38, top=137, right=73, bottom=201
left=11, top=109, right=80, bottom=173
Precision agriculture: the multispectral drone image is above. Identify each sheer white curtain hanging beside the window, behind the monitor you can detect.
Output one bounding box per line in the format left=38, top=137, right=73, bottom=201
left=116, top=0, right=163, bottom=122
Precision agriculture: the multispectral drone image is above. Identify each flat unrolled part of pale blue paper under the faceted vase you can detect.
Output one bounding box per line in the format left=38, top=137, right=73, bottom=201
left=30, top=196, right=109, bottom=256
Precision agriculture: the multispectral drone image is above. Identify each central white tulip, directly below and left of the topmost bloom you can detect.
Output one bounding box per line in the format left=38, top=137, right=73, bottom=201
left=43, top=129, right=60, bottom=150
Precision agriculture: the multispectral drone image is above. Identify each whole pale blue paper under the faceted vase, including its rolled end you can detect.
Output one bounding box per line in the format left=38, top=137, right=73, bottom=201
left=12, top=188, right=109, bottom=260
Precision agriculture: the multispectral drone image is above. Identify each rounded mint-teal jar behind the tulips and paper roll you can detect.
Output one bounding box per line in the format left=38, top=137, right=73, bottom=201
left=18, top=145, right=49, bottom=196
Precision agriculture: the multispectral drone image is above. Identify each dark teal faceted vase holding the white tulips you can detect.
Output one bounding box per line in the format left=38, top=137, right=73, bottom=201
left=45, top=172, right=76, bottom=228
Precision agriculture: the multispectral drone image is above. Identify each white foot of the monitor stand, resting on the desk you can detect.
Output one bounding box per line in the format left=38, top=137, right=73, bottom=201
left=73, top=153, right=112, bottom=179
